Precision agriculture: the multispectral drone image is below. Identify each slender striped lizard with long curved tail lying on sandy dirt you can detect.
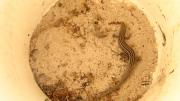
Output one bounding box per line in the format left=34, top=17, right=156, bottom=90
left=95, top=22, right=136, bottom=100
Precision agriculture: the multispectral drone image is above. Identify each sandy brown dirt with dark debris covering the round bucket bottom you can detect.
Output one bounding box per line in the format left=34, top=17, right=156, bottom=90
left=30, top=0, right=158, bottom=101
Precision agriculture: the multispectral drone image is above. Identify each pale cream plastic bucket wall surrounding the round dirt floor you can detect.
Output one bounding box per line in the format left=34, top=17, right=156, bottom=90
left=0, top=0, right=180, bottom=101
